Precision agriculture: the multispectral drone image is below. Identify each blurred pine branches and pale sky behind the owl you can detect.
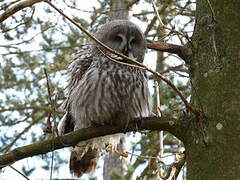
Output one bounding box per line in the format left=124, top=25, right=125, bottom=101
left=0, top=0, right=195, bottom=180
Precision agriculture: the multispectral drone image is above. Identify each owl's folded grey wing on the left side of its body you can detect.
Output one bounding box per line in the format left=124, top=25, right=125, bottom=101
left=58, top=48, right=92, bottom=135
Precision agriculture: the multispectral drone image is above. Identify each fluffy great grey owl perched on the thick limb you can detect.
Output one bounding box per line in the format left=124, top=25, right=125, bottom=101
left=58, top=20, right=150, bottom=177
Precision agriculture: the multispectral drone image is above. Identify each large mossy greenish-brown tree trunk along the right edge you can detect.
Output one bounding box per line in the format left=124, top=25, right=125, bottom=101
left=185, top=0, right=240, bottom=180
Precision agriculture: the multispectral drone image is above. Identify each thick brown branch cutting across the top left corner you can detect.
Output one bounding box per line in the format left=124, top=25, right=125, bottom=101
left=0, top=0, right=43, bottom=22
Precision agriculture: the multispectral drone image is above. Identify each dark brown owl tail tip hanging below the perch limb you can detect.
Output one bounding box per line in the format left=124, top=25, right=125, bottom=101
left=69, top=147, right=99, bottom=177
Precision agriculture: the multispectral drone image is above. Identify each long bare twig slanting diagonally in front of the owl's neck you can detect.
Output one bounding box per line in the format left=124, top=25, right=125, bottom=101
left=45, top=0, right=199, bottom=116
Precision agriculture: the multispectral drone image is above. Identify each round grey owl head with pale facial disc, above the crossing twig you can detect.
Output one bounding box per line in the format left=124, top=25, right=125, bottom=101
left=92, top=20, right=146, bottom=62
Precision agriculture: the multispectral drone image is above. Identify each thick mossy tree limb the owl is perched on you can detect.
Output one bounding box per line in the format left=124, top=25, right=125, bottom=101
left=0, top=117, right=187, bottom=169
